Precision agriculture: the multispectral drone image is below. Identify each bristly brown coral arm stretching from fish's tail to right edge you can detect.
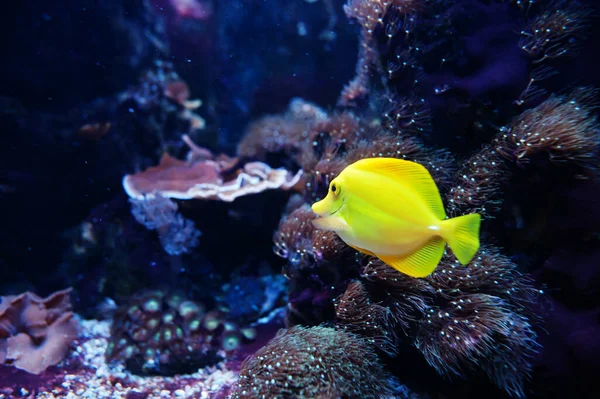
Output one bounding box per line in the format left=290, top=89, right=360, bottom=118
left=446, top=87, right=600, bottom=217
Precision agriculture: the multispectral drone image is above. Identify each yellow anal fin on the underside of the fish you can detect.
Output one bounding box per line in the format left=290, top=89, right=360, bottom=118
left=378, top=236, right=446, bottom=277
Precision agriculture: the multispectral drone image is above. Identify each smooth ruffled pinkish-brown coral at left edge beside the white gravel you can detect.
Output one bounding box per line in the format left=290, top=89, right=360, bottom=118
left=0, top=289, right=77, bottom=374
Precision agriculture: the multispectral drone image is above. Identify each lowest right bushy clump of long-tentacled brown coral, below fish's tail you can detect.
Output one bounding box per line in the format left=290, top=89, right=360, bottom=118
left=415, top=294, right=537, bottom=397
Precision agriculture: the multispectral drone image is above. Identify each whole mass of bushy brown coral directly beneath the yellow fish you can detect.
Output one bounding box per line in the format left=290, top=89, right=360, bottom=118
left=336, top=246, right=539, bottom=397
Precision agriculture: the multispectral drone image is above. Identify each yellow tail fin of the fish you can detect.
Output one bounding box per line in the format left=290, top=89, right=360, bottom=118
left=442, top=213, right=481, bottom=265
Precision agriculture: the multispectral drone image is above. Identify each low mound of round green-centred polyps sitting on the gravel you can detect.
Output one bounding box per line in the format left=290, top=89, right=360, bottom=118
left=106, top=290, right=255, bottom=375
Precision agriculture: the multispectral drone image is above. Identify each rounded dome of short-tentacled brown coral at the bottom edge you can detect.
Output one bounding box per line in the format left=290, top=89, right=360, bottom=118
left=232, top=326, right=404, bottom=399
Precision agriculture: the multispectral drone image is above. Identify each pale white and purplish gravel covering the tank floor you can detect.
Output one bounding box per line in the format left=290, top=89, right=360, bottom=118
left=0, top=320, right=238, bottom=399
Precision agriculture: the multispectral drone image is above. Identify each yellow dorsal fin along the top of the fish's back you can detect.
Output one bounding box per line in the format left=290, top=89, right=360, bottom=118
left=352, top=158, right=446, bottom=220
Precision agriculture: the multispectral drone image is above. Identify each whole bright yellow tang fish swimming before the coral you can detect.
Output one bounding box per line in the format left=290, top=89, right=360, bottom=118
left=312, top=158, right=481, bottom=277
